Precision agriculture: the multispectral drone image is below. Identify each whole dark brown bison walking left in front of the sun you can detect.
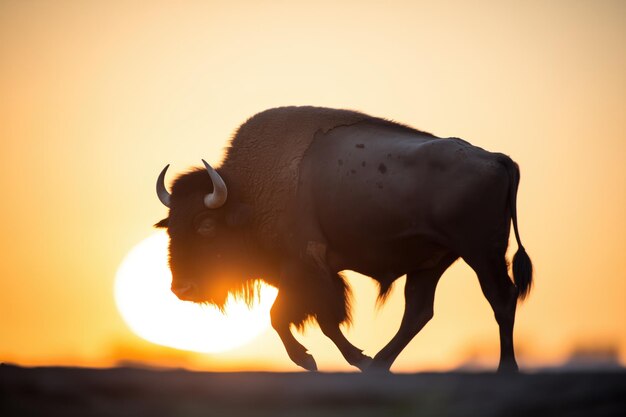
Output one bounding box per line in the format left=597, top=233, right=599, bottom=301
left=155, top=107, right=532, bottom=371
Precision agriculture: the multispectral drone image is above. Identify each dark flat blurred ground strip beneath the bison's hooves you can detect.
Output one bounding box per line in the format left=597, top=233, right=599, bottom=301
left=0, top=365, right=626, bottom=417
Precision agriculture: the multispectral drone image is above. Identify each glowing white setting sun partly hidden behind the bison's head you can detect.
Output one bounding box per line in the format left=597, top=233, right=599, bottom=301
left=115, top=231, right=277, bottom=353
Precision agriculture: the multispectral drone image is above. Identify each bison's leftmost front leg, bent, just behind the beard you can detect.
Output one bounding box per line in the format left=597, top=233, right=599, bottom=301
left=270, top=292, right=317, bottom=371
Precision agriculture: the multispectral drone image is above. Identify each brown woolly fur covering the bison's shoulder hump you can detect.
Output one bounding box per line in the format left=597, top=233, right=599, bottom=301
left=218, top=106, right=434, bottom=248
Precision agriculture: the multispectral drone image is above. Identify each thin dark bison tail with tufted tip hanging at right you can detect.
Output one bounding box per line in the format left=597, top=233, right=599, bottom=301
left=500, top=155, right=533, bottom=300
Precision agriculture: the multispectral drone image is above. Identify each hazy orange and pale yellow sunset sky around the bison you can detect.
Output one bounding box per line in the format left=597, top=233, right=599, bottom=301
left=0, top=1, right=626, bottom=371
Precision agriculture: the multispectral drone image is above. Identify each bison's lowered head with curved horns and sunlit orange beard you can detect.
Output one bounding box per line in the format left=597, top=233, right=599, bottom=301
left=155, top=160, right=259, bottom=308
